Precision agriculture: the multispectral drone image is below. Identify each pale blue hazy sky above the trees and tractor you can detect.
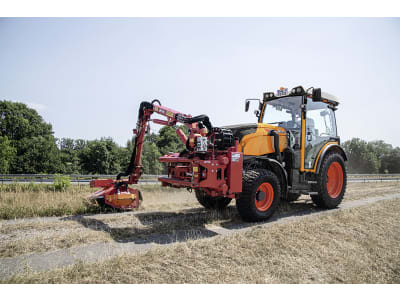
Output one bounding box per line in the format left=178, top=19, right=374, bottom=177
left=0, top=18, right=400, bottom=146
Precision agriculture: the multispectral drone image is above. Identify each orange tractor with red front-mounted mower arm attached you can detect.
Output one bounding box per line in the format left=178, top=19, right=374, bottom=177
left=90, top=86, right=347, bottom=222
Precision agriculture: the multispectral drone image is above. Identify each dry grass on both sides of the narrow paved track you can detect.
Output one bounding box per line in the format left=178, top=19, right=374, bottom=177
left=0, top=182, right=400, bottom=283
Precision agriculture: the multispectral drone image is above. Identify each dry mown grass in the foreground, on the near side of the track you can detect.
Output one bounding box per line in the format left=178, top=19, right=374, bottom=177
left=2, top=199, right=400, bottom=283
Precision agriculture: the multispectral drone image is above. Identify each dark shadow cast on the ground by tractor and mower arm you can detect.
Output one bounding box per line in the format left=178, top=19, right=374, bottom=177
left=63, top=200, right=320, bottom=244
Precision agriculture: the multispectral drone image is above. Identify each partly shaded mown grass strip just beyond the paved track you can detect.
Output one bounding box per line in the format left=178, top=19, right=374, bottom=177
left=0, top=183, right=399, bottom=257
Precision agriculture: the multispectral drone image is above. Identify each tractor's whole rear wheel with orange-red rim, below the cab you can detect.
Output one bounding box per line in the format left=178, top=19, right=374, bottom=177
left=311, top=153, right=347, bottom=208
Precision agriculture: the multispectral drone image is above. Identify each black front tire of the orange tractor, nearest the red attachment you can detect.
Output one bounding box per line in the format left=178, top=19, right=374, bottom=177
left=236, top=169, right=281, bottom=222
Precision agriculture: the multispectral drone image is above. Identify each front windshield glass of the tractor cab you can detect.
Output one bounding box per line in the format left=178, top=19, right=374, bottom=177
left=263, top=96, right=302, bottom=129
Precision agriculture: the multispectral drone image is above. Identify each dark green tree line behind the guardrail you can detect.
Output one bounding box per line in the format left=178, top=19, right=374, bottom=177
left=0, top=100, right=400, bottom=174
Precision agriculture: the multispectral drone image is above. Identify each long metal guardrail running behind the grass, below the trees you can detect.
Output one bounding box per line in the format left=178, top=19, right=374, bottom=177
left=0, top=174, right=400, bottom=184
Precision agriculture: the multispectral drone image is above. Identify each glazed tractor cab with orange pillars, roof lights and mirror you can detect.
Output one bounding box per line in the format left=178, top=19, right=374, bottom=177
left=246, top=86, right=340, bottom=172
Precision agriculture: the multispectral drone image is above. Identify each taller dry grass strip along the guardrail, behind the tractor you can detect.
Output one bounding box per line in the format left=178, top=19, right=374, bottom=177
left=0, top=182, right=400, bottom=219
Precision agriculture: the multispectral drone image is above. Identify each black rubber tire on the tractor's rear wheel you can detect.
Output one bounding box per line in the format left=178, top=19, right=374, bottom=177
left=311, top=153, right=347, bottom=209
